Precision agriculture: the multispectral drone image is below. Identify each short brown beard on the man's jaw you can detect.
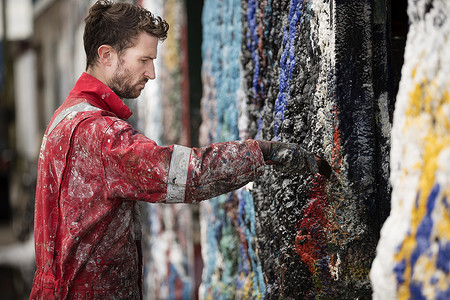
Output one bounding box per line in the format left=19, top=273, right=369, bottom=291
left=108, top=63, right=147, bottom=99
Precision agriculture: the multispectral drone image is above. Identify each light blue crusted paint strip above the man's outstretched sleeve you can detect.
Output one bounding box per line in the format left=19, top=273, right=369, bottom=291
left=202, top=0, right=241, bottom=142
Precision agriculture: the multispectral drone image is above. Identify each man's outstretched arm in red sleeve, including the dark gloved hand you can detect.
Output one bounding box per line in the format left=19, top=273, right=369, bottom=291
left=102, top=121, right=330, bottom=203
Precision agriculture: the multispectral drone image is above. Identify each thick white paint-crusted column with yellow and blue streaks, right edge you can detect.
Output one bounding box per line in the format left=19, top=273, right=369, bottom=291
left=371, top=0, right=450, bottom=299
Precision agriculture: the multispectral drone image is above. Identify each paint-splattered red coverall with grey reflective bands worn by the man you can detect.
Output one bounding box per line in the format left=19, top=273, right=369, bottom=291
left=30, top=73, right=264, bottom=299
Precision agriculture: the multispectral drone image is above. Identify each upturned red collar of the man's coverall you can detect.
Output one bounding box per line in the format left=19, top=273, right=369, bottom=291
left=70, top=72, right=133, bottom=120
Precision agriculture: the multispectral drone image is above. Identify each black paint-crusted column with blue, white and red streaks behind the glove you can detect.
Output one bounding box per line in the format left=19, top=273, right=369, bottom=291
left=245, top=1, right=384, bottom=298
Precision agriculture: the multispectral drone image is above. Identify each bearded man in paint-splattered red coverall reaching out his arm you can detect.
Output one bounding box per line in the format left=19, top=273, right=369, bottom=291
left=30, top=1, right=329, bottom=299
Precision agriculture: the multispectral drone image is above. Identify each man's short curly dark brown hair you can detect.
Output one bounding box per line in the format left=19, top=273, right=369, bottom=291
left=83, top=0, right=169, bottom=70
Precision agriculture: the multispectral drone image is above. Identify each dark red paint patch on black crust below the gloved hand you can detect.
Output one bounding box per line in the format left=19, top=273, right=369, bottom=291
left=295, top=174, right=328, bottom=273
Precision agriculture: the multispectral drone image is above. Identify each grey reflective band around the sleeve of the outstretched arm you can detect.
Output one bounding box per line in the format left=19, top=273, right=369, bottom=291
left=166, top=145, right=191, bottom=203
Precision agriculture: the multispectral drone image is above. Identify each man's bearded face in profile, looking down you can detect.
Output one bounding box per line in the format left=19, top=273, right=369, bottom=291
left=108, top=32, right=158, bottom=99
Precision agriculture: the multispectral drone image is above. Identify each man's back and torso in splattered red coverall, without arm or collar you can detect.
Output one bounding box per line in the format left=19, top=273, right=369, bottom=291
left=30, top=98, right=140, bottom=299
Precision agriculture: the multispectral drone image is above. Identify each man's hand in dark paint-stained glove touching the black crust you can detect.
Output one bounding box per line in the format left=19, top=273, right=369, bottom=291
left=258, top=141, right=331, bottom=178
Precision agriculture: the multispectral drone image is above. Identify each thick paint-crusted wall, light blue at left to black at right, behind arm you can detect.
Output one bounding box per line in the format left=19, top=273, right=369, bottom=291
left=200, top=0, right=393, bottom=299
